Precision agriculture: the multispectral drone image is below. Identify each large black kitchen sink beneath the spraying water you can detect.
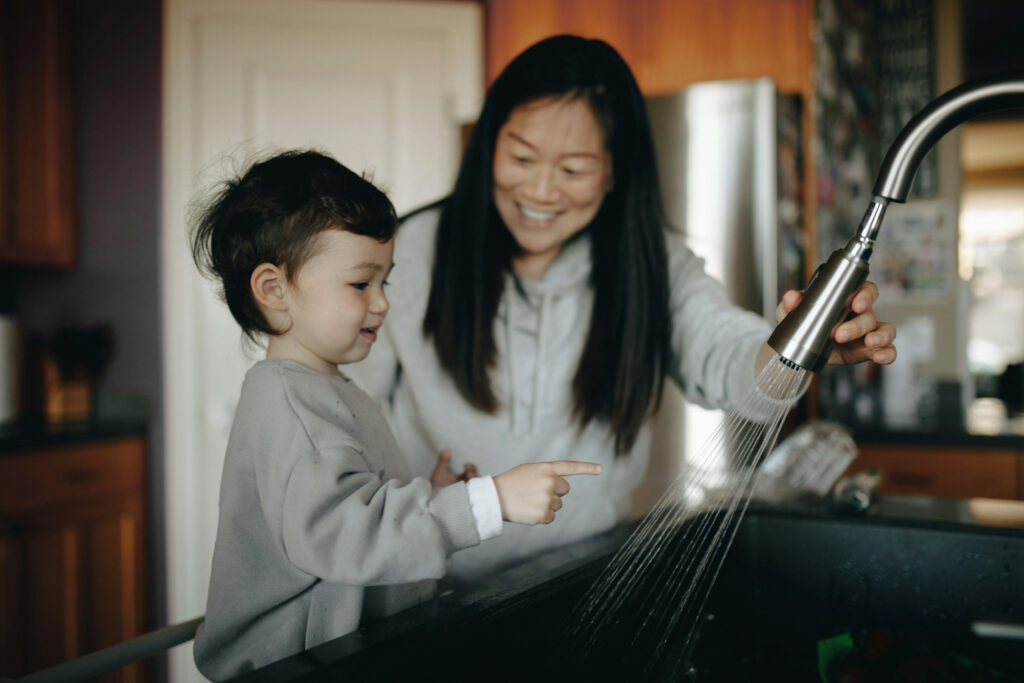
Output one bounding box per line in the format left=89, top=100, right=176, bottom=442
left=232, top=507, right=1024, bottom=683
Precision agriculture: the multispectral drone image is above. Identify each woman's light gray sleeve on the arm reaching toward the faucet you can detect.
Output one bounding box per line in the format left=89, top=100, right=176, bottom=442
left=667, top=233, right=771, bottom=411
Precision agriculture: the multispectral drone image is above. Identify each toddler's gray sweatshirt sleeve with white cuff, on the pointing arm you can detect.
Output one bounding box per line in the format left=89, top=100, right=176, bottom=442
left=282, top=442, right=479, bottom=586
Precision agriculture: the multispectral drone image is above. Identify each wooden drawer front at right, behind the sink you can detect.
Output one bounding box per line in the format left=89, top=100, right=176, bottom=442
left=850, top=443, right=1024, bottom=499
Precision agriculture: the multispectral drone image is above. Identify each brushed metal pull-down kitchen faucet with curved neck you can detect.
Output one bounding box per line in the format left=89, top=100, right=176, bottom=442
left=768, top=74, right=1024, bottom=372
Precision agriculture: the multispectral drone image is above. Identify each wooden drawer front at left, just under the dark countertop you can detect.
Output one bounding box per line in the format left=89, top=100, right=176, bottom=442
left=0, top=438, right=145, bottom=513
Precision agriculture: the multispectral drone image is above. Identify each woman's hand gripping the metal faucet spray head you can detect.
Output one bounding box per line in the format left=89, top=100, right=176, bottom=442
left=775, top=282, right=896, bottom=366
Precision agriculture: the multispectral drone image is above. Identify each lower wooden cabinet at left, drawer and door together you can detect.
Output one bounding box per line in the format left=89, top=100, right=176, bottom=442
left=0, top=437, right=146, bottom=681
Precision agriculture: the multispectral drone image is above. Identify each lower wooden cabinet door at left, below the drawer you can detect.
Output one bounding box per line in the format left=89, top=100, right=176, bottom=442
left=0, top=499, right=144, bottom=682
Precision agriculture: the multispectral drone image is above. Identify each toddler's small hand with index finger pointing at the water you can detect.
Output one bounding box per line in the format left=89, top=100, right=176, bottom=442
left=495, top=460, right=601, bottom=524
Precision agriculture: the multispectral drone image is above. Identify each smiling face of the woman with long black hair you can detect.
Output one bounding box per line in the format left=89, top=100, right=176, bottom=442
left=494, top=97, right=612, bottom=280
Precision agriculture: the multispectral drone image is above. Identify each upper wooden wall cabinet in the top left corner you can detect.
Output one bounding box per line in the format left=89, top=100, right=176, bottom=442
left=0, top=0, right=78, bottom=268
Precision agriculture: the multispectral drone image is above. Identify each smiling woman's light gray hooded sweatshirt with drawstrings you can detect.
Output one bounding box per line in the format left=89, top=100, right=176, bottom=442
left=346, top=209, right=771, bottom=582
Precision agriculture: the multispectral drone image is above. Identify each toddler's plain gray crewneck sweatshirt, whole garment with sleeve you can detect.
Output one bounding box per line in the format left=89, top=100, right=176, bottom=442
left=195, top=360, right=479, bottom=680
